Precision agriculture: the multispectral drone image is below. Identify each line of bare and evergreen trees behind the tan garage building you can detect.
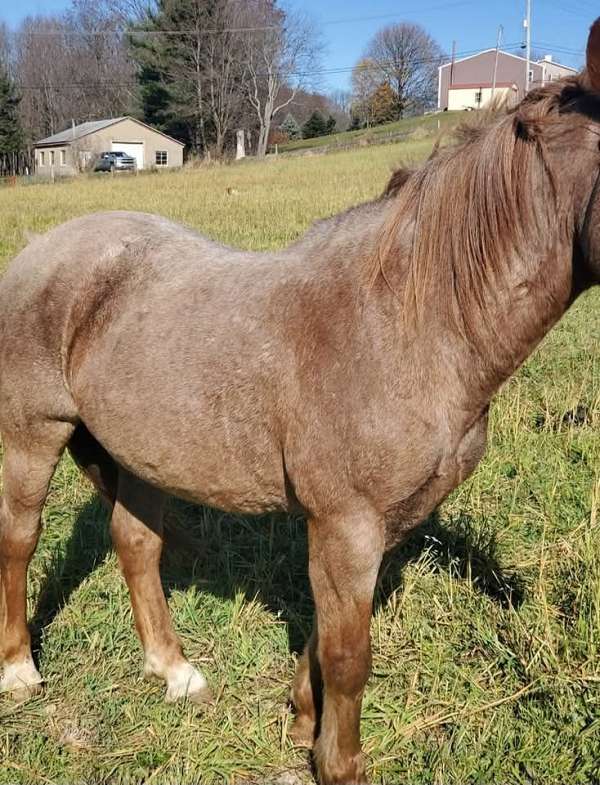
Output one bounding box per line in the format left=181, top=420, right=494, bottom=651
left=0, top=0, right=441, bottom=174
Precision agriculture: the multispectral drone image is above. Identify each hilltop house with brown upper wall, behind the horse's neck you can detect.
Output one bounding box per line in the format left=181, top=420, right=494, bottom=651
left=438, top=49, right=577, bottom=111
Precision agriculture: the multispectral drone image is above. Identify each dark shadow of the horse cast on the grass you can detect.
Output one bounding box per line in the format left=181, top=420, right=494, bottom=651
left=32, top=500, right=523, bottom=652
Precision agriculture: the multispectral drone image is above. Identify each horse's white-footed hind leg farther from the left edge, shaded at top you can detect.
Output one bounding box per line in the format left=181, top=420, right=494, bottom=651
left=111, top=470, right=211, bottom=703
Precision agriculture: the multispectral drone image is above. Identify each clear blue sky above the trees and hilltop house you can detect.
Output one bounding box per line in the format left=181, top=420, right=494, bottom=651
left=0, top=0, right=600, bottom=89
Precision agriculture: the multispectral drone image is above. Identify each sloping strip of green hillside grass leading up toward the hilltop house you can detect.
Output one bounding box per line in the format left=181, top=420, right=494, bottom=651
left=279, top=112, right=465, bottom=153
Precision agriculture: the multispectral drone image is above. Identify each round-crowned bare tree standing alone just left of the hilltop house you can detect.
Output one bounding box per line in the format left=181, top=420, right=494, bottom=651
left=366, top=22, right=443, bottom=119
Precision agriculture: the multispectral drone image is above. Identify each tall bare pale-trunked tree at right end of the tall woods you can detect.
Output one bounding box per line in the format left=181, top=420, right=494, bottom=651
left=242, top=0, right=322, bottom=158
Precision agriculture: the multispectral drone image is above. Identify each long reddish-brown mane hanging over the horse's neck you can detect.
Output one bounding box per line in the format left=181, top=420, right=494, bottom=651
left=376, top=77, right=596, bottom=337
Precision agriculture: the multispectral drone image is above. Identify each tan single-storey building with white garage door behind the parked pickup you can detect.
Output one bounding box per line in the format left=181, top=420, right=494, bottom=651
left=34, top=117, right=184, bottom=176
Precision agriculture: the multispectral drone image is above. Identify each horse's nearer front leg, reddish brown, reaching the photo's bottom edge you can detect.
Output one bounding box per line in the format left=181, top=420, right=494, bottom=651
left=309, top=506, right=385, bottom=785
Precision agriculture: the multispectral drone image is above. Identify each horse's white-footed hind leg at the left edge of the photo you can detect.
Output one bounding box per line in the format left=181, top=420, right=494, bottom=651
left=0, top=422, right=73, bottom=697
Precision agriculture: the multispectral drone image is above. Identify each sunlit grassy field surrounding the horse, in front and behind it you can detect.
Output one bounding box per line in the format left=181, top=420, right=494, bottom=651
left=0, top=136, right=600, bottom=785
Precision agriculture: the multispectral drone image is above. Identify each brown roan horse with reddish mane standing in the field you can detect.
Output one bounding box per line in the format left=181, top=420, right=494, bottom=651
left=0, top=19, right=600, bottom=785
